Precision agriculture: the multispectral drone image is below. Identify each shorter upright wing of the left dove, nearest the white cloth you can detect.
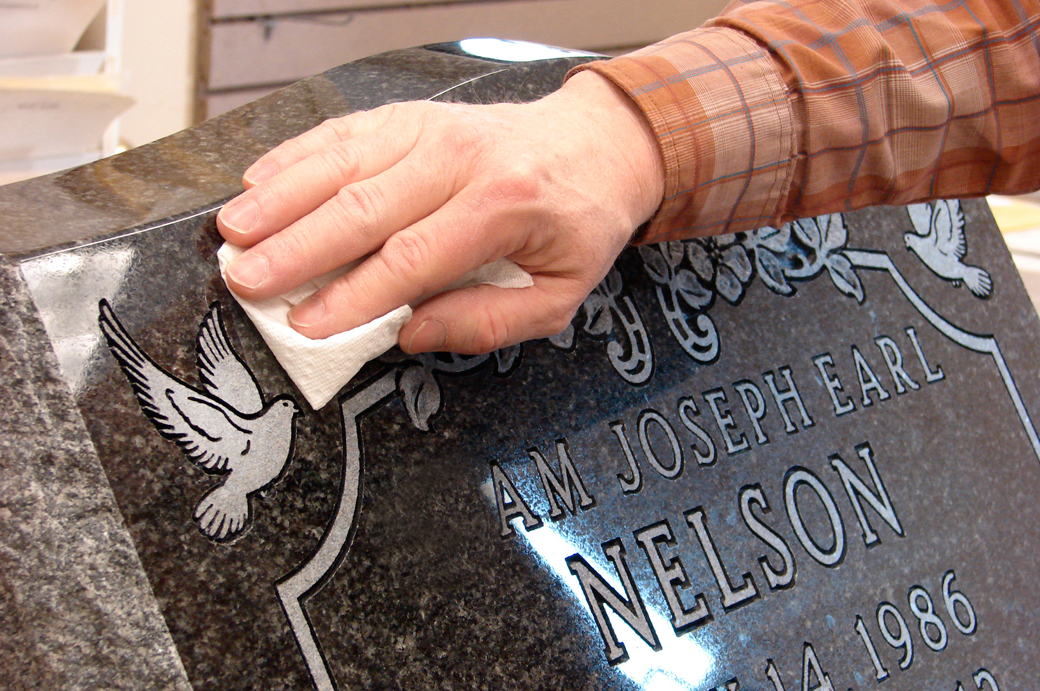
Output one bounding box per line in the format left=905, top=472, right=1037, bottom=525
left=196, top=302, right=263, bottom=415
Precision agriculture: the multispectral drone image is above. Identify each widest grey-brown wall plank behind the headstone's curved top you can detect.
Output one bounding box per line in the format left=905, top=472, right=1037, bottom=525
left=209, top=0, right=724, bottom=91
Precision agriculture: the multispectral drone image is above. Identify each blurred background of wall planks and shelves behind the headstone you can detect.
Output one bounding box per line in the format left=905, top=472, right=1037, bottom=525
left=0, top=0, right=1040, bottom=304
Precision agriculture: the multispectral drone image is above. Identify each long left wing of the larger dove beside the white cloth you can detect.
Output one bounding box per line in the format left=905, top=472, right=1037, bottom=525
left=98, top=300, right=252, bottom=472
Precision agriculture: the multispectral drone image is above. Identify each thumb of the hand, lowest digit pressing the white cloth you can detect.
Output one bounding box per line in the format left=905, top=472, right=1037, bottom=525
left=399, top=276, right=588, bottom=355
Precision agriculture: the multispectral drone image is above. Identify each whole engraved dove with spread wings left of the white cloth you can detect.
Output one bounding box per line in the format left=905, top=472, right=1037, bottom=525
left=98, top=300, right=301, bottom=542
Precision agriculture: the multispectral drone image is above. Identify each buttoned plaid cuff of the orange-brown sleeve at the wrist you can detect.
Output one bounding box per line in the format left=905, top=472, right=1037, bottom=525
left=575, top=27, right=797, bottom=242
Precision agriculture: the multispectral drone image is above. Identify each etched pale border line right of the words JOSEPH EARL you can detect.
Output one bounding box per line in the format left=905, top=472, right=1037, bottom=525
left=844, top=250, right=1040, bottom=460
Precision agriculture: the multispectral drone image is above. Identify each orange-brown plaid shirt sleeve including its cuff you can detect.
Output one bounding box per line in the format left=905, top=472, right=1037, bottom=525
left=586, top=0, right=1040, bottom=241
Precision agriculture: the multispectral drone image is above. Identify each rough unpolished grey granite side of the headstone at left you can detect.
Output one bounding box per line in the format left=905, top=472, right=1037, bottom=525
left=0, top=260, right=190, bottom=691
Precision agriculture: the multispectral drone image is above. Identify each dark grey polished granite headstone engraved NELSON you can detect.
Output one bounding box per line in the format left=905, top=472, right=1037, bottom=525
left=0, top=39, right=1040, bottom=691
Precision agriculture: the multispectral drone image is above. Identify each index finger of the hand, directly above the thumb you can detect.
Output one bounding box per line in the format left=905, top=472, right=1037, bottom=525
left=289, top=190, right=519, bottom=338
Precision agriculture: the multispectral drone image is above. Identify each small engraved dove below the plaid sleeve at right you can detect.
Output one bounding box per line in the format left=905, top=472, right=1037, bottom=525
left=903, top=200, right=993, bottom=298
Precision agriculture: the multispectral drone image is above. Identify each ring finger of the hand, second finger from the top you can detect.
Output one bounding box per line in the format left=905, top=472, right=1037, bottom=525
left=216, top=128, right=414, bottom=247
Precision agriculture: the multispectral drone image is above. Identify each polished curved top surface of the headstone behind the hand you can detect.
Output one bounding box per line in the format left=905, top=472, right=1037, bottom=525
left=0, top=40, right=595, bottom=256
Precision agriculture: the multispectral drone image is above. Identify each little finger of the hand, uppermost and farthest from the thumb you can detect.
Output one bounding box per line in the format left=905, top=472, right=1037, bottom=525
left=242, top=104, right=405, bottom=189
